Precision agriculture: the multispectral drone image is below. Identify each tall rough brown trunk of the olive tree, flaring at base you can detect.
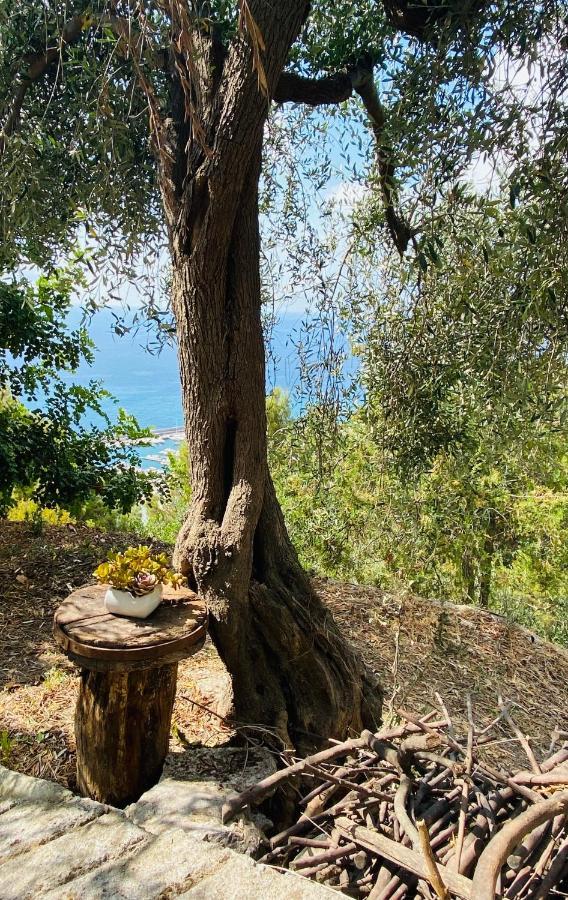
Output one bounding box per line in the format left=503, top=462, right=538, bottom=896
left=156, top=0, right=380, bottom=751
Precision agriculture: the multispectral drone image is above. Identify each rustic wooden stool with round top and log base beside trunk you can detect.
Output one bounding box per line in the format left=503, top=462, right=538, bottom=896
left=53, top=585, right=207, bottom=806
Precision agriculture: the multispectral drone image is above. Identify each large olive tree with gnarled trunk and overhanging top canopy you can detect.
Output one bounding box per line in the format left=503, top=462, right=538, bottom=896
left=0, top=0, right=556, bottom=748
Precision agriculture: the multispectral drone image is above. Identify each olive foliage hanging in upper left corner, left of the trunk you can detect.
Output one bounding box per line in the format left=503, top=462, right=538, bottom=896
left=0, top=0, right=159, bottom=268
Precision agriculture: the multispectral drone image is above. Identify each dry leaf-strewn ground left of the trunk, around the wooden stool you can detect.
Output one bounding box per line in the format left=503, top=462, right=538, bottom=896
left=0, top=521, right=232, bottom=789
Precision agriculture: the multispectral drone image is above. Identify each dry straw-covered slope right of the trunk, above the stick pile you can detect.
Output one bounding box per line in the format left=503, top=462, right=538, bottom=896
left=316, top=579, right=568, bottom=766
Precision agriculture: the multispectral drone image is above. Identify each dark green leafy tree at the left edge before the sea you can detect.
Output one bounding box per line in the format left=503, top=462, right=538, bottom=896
left=0, top=271, right=152, bottom=513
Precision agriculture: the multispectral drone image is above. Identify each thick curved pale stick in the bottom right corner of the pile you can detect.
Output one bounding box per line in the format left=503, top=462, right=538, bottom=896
left=471, top=791, right=568, bottom=900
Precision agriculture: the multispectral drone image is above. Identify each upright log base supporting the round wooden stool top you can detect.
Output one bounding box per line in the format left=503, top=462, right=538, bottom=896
left=75, top=663, right=177, bottom=807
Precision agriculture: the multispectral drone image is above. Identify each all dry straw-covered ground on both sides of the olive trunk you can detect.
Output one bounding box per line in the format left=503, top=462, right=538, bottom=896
left=0, top=522, right=568, bottom=788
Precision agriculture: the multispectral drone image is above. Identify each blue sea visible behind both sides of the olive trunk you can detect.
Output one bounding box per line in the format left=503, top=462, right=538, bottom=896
left=69, top=308, right=348, bottom=468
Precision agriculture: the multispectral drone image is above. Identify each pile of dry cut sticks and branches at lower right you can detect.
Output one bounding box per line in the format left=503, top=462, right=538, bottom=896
left=223, top=699, right=568, bottom=900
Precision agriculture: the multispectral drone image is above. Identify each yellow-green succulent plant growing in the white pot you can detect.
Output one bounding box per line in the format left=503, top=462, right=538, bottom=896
left=93, top=545, right=185, bottom=597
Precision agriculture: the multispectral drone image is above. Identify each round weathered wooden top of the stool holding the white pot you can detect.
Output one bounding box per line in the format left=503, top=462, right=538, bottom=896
left=53, top=584, right=207, bottom=672
